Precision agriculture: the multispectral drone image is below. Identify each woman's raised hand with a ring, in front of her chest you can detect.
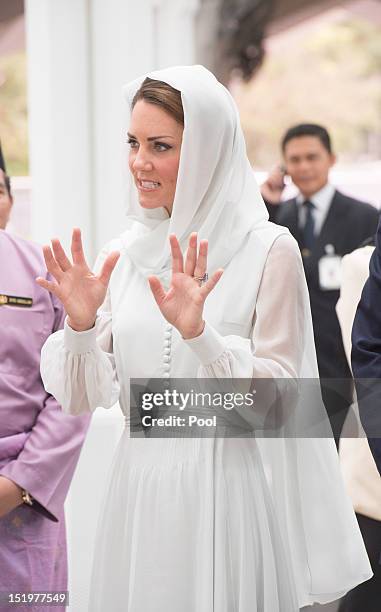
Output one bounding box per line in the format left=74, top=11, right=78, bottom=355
left=148, top=233, right=223, bottom=339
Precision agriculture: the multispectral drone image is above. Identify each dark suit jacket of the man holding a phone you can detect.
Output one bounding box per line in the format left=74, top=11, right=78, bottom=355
left=276, top=191, right=379, bottom=379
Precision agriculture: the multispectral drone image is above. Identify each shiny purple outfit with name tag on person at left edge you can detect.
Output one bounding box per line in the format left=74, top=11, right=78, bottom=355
left=0, top=230, right=90, bottom=612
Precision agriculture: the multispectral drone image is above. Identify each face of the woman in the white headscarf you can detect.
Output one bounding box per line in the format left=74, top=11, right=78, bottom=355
left=128, top=100, right=183, bottom=214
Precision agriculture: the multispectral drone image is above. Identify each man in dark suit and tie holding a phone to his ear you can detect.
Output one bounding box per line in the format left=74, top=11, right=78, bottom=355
left=261, top=124, right=379, bottom=441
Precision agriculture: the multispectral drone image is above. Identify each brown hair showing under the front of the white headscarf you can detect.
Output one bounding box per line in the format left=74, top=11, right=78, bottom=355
left=132, top=77, right=184, bottom=125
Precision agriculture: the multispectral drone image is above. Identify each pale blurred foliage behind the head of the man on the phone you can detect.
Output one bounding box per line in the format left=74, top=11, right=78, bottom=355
left=236, top=18, right=381, bottom=168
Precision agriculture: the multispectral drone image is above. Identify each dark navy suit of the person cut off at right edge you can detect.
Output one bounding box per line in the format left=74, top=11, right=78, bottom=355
left=352, top=215, right=381, bottom=474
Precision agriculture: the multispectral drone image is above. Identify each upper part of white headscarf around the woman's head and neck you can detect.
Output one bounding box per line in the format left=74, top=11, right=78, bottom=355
left=124, top=66, right=268, bottom=276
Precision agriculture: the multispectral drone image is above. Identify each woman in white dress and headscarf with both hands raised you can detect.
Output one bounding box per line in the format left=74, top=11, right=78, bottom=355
left=38, top=66, right=371, bottom=612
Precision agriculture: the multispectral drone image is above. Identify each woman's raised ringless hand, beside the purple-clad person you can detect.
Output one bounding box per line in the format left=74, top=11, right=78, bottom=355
left=36, top=228, right=119, bottom=331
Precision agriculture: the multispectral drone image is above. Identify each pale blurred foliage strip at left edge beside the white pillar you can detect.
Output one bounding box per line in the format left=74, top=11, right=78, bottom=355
left=0, top=53, right=29, bottom=176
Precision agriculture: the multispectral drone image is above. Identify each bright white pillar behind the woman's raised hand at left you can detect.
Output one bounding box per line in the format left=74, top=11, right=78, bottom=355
left=25, top=0, right=93, bottom=256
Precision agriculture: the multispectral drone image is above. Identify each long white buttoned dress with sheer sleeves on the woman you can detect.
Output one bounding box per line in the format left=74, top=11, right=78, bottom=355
left=42, top=224, right=369, bottom=612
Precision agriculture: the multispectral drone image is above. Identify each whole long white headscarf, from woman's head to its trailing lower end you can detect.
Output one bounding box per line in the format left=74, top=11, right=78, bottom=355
left=122, top=66, right=371, bottom=607
